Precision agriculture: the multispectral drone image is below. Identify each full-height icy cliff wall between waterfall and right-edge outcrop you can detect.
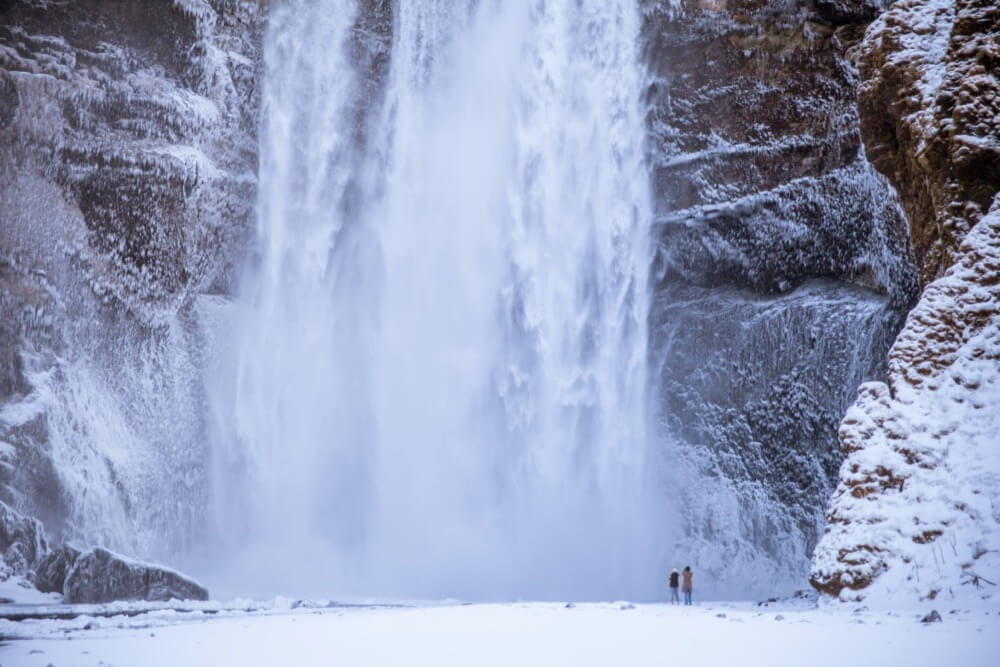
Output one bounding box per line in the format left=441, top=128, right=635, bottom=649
left=643, top=0, right=916, bottom=595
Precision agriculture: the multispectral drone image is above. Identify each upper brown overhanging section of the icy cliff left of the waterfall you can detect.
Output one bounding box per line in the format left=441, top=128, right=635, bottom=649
left=0, top=0, right=261, bottom=321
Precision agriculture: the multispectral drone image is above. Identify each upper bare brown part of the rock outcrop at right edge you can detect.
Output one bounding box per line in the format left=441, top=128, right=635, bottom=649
left=858, top=0, right=1000, bottom=284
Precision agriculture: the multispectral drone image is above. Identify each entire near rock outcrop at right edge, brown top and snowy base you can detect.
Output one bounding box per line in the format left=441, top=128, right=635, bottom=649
left=811, top=0, right=1000, bottom=603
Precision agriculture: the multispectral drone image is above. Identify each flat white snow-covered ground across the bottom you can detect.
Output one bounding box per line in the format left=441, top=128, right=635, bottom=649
left=0, top=601, right=1000, bottom=667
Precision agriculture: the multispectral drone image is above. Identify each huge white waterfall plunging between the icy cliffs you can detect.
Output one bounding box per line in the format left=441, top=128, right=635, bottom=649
left=208, top=0, right=669, bottom=599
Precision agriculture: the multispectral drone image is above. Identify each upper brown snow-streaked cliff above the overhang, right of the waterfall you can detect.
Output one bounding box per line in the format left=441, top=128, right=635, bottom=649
left=645, top=0, right=912, bottom=298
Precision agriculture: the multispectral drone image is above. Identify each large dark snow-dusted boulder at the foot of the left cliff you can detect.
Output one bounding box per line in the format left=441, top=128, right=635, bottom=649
left=63, top=547, right=208, bottom=604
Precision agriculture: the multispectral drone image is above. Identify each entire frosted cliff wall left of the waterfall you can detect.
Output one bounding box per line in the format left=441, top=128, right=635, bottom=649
left=0, top=0, right=262, bottom=556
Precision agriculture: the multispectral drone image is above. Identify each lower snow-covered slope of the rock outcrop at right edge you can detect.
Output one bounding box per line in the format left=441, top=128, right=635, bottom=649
left=811, top=204, right=1000, bottom=602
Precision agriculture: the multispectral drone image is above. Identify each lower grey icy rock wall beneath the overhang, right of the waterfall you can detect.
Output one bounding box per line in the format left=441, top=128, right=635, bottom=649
left=651, top=280, right=896, bottom=595
